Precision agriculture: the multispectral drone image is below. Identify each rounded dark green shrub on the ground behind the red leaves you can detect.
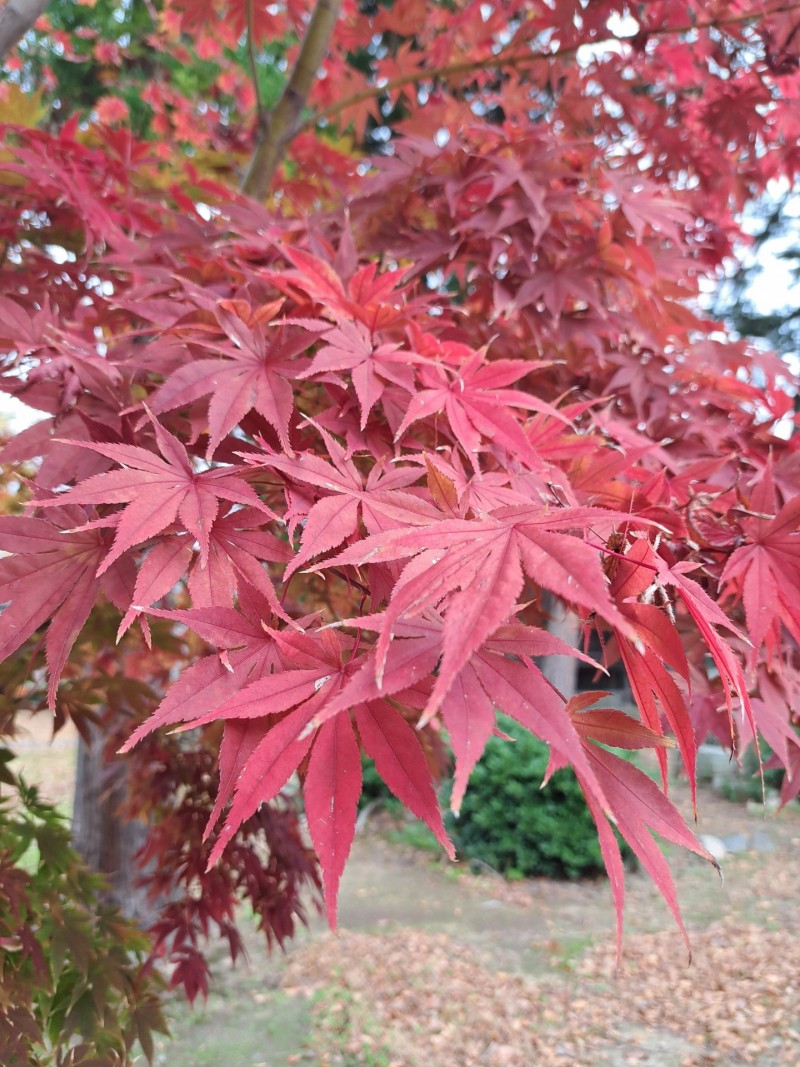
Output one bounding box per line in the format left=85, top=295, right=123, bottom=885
left=448, top=716, right=605, bottom=878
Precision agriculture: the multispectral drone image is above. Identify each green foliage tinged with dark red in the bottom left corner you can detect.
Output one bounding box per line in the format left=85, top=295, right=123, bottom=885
left=0, top=747, right=166, bottom=1067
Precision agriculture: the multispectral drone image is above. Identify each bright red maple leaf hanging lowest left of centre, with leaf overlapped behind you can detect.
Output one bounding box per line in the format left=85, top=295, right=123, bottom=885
left=125, top=608, right=452, bottom=924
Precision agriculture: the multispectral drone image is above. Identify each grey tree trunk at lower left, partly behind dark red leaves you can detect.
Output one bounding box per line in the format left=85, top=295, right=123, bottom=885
left=73, top=726, right=155, bottom=926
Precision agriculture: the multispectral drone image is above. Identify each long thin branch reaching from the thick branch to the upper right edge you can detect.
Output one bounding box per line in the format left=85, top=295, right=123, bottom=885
left=309, top=3, right=800, bottom=128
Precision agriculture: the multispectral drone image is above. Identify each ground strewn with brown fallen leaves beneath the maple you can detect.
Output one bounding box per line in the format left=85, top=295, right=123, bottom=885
left=6, top=717, right=800, bottom=1067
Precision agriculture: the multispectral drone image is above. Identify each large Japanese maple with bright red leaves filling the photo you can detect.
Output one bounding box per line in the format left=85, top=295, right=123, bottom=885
left=0, top=0, right=800, bottom=998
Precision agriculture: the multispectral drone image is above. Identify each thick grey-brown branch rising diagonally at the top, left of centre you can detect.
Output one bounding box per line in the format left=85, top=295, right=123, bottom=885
left=242, top=0, right=341, bottom=201
